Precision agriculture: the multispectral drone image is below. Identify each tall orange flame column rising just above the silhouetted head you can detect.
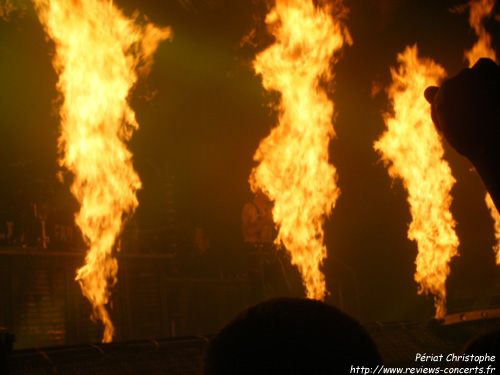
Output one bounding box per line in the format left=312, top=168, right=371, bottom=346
left=250, top=0, right=352, bottom=299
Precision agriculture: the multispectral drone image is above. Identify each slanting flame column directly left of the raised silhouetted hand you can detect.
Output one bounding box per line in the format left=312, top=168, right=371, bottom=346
left=374, top=45, right=459, bottom=318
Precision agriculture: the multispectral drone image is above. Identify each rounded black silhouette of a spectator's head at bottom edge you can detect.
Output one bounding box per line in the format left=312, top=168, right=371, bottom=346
left=205, top=298, right=382, bottom=375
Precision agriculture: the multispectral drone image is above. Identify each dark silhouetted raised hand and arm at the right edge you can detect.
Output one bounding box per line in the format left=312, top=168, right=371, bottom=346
left=424, top=58, right=500, bottom=212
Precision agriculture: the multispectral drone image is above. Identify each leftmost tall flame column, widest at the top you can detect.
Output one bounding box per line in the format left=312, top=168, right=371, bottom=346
left=34, top=0, right=170, bottom=342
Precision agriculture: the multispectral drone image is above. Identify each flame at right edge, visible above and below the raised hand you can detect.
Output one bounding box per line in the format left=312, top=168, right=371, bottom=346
left=465, top=0, right=500, bottom=265
